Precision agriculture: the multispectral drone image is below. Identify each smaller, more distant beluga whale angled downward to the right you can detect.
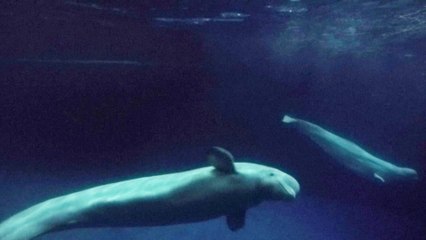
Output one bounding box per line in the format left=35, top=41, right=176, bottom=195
left=282, top=115, right=418, bottom=183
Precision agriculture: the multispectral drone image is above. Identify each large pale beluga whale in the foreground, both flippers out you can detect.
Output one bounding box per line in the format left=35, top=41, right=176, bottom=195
left=0, top=147, right=299, bottom=240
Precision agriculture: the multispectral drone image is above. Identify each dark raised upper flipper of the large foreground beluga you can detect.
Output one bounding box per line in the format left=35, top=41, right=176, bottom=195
left=207, top=147, right=235, bottom=173
